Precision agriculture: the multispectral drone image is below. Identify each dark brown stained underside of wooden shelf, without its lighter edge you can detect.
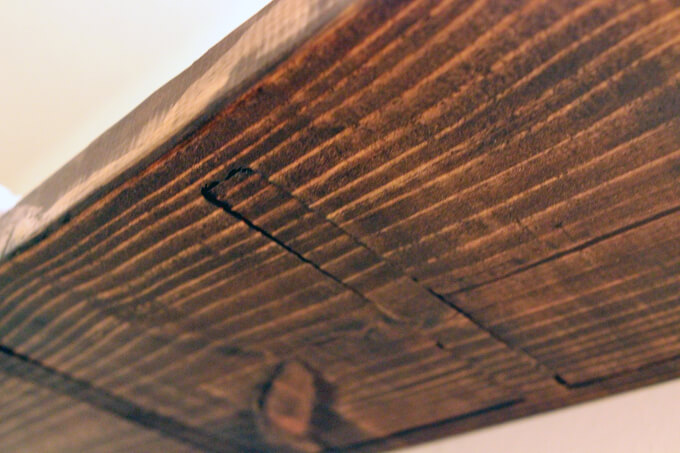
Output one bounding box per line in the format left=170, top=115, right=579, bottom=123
left=0, top=0, right=680, bottom=452
